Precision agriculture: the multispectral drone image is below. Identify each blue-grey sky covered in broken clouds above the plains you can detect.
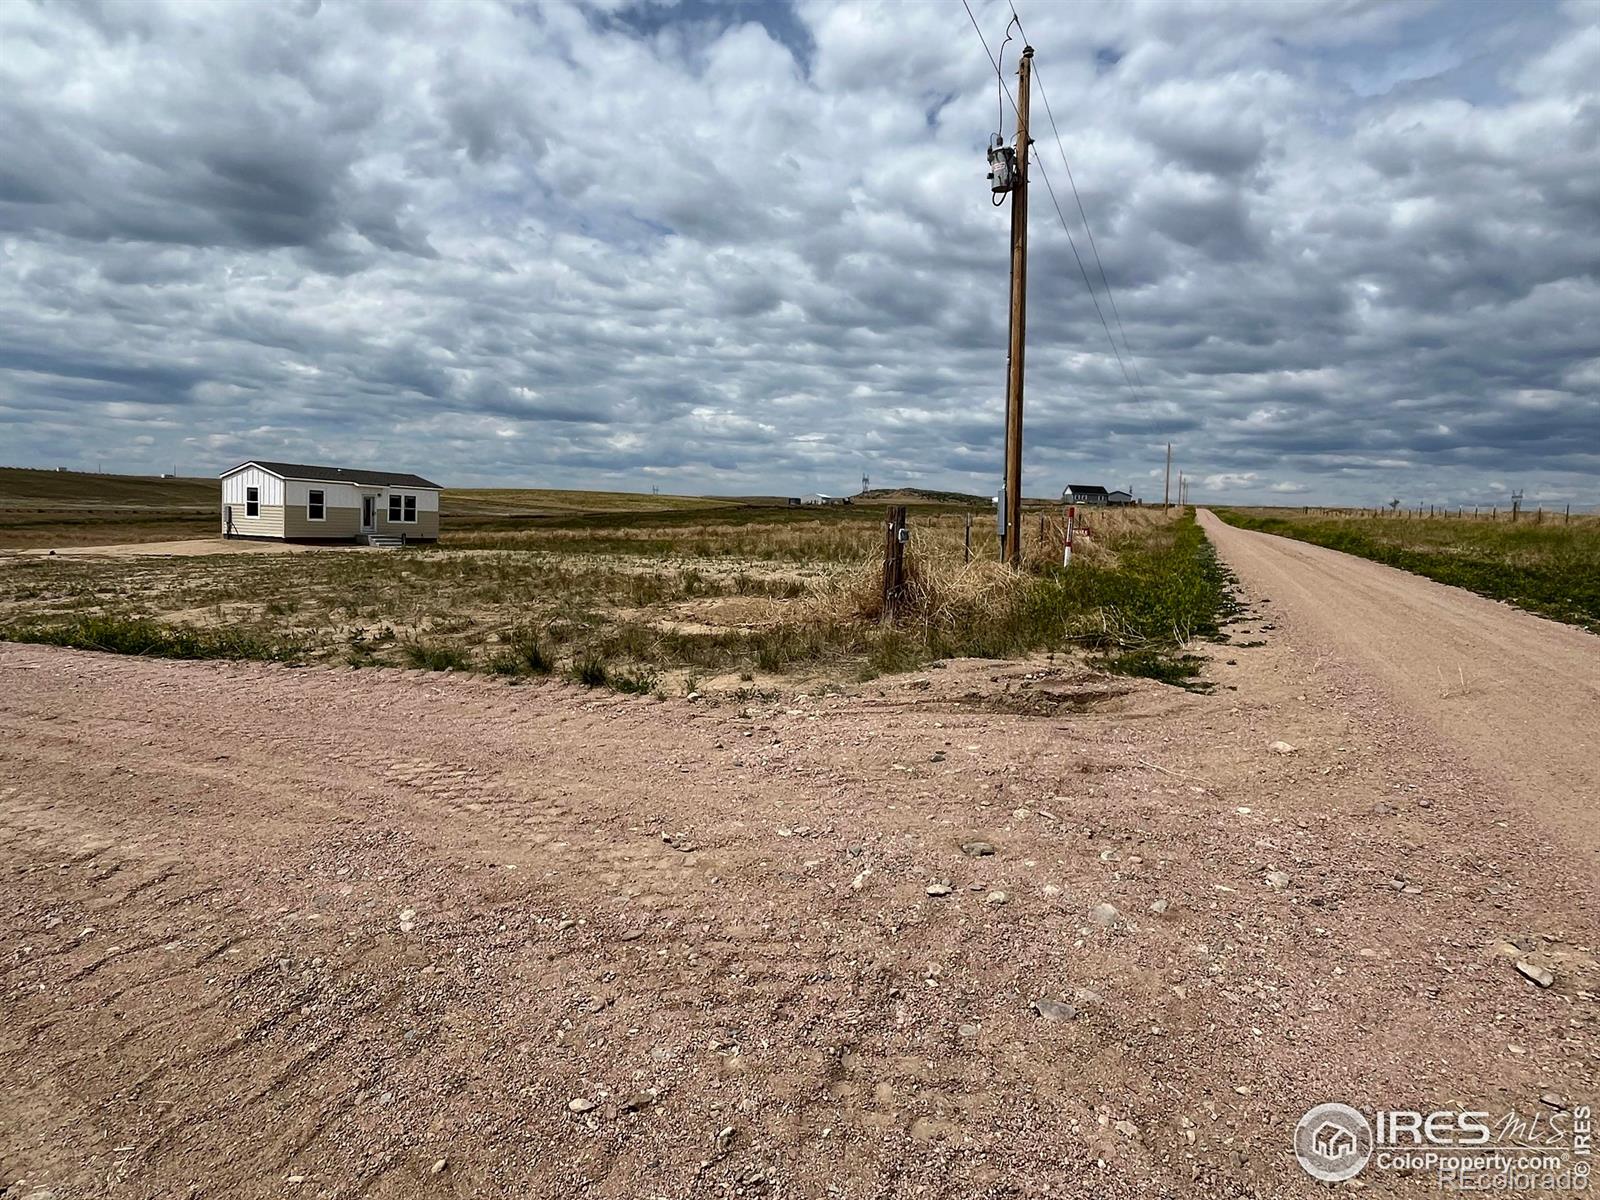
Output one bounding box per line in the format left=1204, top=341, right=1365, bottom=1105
left=0, top=0, right=1600, bottom=507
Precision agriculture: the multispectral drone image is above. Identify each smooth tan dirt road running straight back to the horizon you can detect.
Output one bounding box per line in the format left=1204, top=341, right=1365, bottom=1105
left=1200, top=512, right=1600, bottom=854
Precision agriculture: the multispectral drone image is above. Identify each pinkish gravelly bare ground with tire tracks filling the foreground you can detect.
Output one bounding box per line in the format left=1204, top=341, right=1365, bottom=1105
left=0, top=547, right=1600, bottom=1200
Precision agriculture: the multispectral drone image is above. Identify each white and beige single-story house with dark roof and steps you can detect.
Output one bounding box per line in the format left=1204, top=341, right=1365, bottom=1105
left=222, top=459, right=440, bottom=546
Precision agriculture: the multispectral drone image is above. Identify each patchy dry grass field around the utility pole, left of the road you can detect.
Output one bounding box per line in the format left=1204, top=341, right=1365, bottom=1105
left=0, top=473, right=1226, bottom=693
